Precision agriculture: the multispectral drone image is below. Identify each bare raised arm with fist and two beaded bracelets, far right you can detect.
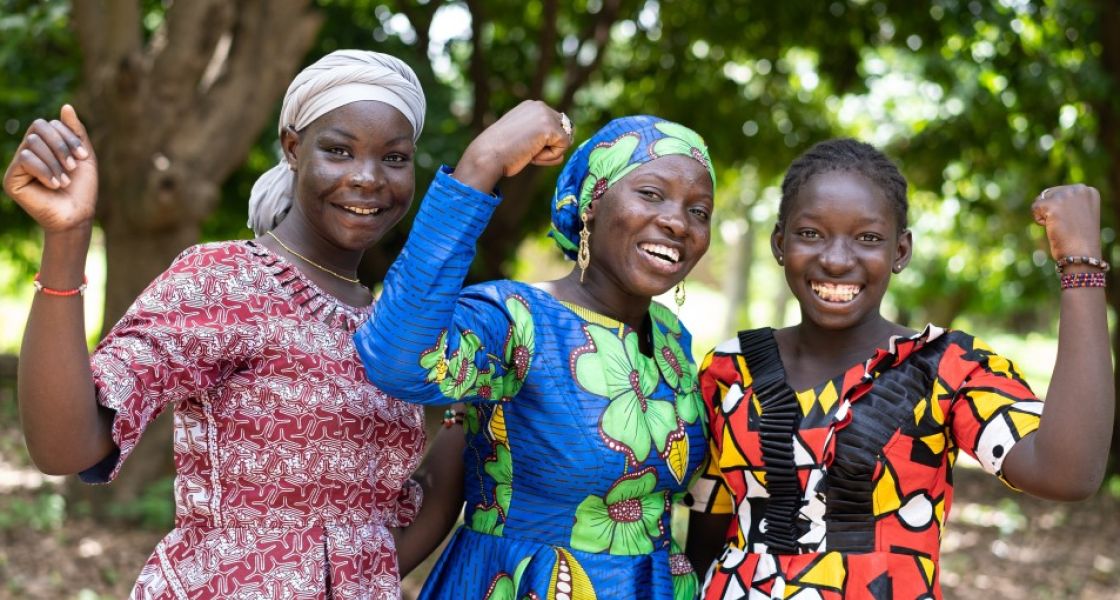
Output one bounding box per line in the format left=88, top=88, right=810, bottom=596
left=1004, top=185, right=1116, bottom=500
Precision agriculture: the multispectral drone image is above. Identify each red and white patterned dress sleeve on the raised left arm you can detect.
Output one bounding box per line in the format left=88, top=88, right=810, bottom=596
left=78, top=249, right=241, bottom=484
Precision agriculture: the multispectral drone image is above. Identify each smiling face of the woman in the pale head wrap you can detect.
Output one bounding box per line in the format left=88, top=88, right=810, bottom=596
left=281, top=101, right=416, bottom=252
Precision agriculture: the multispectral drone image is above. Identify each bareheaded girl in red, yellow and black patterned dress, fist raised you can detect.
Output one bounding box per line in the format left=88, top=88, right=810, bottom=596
left=688, top=140, right=1116, bottom=599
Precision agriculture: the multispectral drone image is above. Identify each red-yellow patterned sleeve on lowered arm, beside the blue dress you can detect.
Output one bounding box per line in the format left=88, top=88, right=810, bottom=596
left=689, top=350, right=741, bottom=515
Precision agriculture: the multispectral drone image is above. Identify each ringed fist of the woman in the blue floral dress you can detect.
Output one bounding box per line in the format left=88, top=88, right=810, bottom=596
left=455, top=100, right=571, bottom=191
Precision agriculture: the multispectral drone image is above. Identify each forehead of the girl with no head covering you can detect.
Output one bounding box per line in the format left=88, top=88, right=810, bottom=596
left=788, top=170, right=895, bottom=223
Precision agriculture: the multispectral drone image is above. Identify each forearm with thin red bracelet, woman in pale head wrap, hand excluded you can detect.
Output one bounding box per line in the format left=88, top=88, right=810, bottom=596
left=19, top=227, right=113, bottom=475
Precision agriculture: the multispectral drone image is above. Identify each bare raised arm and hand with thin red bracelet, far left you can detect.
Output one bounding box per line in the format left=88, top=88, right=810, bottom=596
left=3, top=105, right=113, bottom=475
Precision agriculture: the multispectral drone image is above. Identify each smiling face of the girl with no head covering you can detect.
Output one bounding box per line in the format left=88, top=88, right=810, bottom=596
left=771, top=170, right=912, bottom=329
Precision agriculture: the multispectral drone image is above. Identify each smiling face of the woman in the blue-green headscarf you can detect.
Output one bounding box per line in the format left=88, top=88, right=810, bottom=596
left=588, top=154, right=712, bottom=300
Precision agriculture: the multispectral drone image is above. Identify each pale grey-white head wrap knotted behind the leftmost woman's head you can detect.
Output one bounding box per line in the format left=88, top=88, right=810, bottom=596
left=249, top=50, right=426, bottom=235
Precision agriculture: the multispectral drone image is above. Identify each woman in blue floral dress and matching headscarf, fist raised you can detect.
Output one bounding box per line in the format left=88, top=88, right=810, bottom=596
left=355, top=102, right=716, bottom=600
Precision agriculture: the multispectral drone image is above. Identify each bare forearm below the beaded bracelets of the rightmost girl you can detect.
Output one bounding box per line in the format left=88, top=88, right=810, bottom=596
left=1004, top=278, right=1116, bottom=500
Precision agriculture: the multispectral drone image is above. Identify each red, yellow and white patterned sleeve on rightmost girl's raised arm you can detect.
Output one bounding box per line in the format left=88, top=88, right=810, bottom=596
left=950, top=339, right=1043, bottom=482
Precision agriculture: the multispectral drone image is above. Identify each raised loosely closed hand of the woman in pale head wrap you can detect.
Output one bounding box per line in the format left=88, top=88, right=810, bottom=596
left=3, top=104, right=97, bottom=233
